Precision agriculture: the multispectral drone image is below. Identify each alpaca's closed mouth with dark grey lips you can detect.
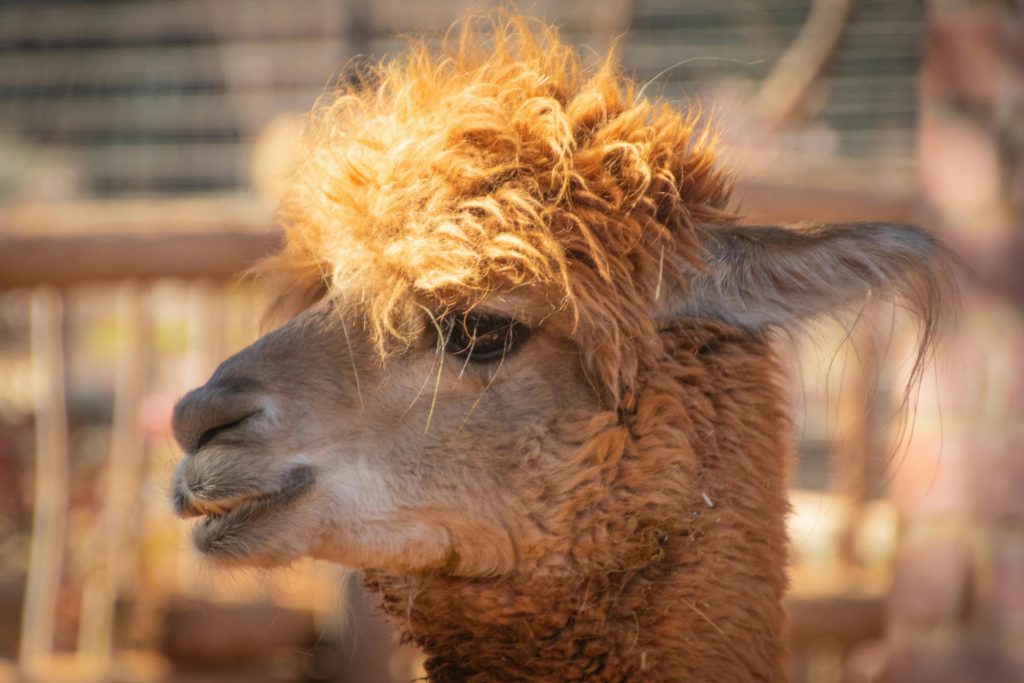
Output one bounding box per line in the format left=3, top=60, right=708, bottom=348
left=184, top=466, right=314, bottom=555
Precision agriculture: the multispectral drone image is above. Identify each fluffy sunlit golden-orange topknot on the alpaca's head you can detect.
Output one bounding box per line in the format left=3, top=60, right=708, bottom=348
left=260, top=17, right=729, bottom=395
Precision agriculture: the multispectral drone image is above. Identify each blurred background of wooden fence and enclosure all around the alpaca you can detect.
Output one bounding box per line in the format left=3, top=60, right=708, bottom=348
left=0, top=0, right=1024, bottom=683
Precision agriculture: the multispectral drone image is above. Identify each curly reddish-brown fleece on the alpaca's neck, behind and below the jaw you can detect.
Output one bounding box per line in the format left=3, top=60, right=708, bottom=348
left=367, top=325, right=792, bottom=681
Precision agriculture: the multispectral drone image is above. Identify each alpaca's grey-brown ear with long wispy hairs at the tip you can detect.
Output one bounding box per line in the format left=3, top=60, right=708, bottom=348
left=656, top=223, right=951, bottom=331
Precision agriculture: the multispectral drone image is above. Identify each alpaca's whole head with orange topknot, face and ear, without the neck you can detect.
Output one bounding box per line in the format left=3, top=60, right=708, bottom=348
left=174, top=15, right=939, bottom=575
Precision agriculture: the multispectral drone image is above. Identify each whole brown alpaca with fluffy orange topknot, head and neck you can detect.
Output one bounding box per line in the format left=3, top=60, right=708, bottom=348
left=173, top=18, right=945, bottom=681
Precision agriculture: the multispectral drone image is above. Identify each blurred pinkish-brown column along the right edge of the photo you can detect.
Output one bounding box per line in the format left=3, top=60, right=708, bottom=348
left=885, top=0, right=1024, bottom=683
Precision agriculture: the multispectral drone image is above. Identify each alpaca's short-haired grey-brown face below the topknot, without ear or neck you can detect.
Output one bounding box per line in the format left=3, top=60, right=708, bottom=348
left=167, top=292, right=598, bottom=574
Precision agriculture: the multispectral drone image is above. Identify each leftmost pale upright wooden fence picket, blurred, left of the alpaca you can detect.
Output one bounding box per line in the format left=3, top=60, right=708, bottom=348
left=18, top=287, right=69, bottom=674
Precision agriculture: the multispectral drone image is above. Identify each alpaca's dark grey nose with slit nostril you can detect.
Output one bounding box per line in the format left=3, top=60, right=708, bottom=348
left=171, top=379, right=262, bottom=455
